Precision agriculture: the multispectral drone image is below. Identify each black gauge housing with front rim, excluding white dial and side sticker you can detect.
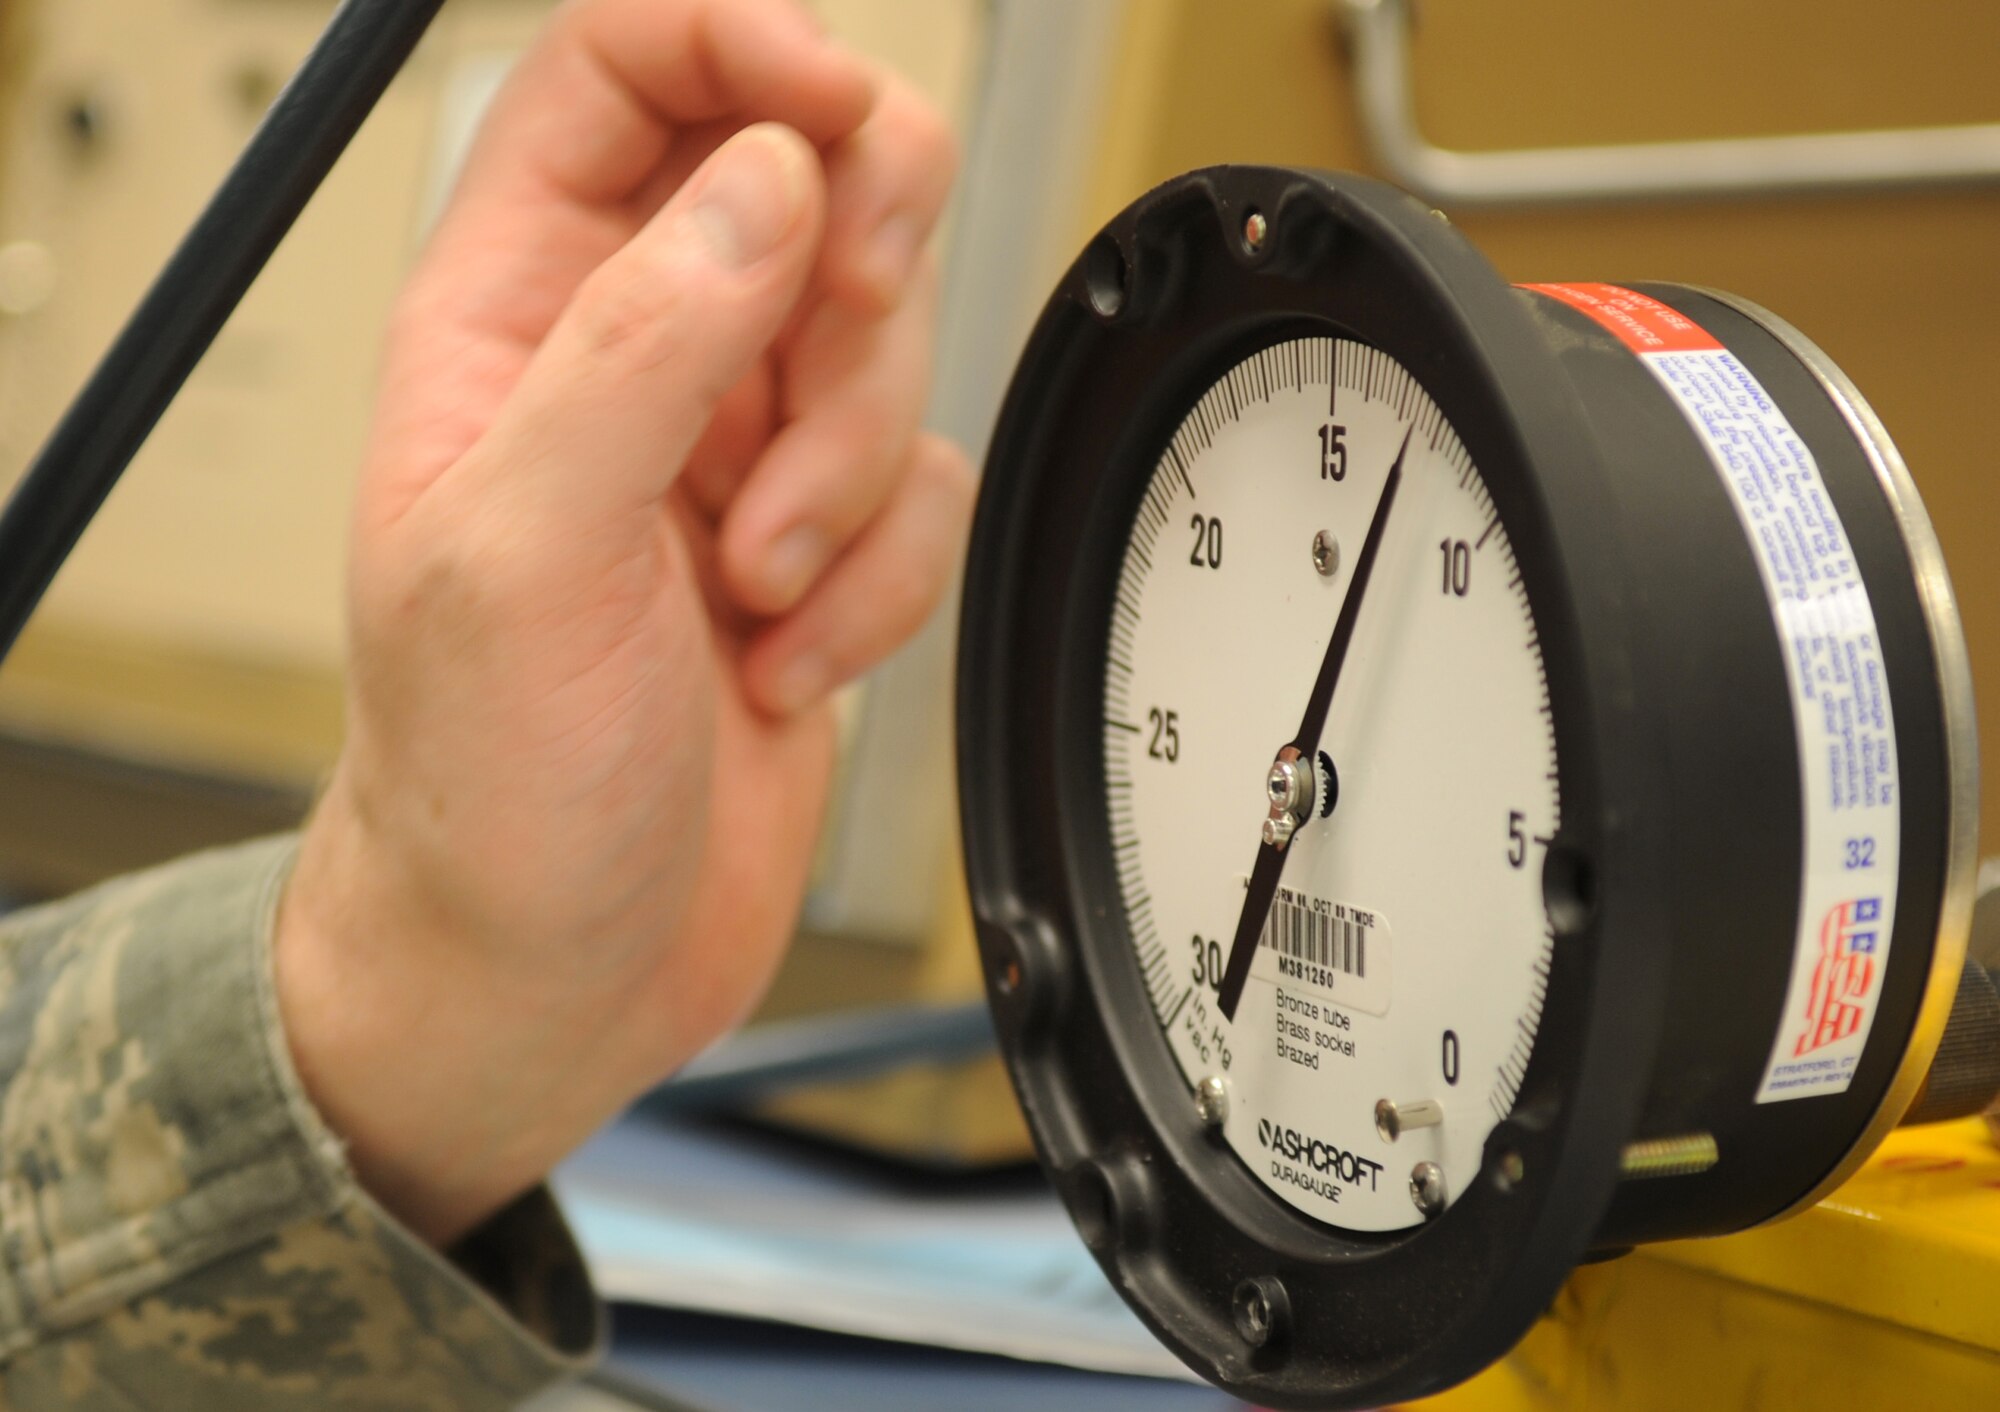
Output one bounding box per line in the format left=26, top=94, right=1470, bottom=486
left=958, top=166, right=1976, bottom=1408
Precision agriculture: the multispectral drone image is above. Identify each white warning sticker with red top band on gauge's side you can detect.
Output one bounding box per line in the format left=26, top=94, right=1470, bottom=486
left=1528, top=284, right=1902, bottom=1102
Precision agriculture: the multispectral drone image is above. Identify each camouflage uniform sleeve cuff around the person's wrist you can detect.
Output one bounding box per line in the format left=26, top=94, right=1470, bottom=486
left=0, top=840, right=602, bottom=1412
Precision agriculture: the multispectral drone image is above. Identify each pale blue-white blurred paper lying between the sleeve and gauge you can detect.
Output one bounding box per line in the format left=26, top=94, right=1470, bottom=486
left=556, top=1118, right=1186, bottom=1380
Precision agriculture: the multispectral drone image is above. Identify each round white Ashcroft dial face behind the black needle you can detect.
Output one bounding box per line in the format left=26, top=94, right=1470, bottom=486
left=1104, top=338, right=1560, bottom=1230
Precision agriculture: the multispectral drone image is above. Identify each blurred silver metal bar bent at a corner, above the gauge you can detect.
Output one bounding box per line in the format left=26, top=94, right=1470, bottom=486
left=1332, top=0, right=2000, bottom=206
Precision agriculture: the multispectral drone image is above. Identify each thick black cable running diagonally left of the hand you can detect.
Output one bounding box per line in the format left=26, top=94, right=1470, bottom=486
left=0, top=0, right=444, bottom=658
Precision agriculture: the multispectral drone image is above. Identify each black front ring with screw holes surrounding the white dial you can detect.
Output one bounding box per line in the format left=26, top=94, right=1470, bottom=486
left=960, top=168, right=1668, bottom=1406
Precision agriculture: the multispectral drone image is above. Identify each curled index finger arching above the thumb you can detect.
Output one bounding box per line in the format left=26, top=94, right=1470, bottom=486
left=378, top=0, right=874, bottom=490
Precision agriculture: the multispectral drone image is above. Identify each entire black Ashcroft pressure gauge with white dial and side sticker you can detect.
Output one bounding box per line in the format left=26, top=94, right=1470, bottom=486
left=958, top=168, right=2000, bottom=1406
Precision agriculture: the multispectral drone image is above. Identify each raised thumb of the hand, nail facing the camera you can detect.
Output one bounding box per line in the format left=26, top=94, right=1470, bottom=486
left=472, top=124, right=826, bottom=522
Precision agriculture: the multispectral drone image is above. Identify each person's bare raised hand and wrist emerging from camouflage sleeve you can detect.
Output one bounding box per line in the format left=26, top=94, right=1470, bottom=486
left=276, top=0, right=972, bottom=1244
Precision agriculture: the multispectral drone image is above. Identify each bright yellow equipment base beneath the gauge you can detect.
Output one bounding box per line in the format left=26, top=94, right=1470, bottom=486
left=1410, top=1118, right=2000, bottom=1412
